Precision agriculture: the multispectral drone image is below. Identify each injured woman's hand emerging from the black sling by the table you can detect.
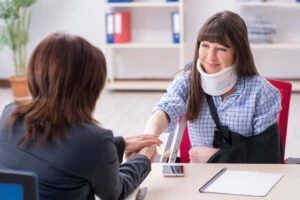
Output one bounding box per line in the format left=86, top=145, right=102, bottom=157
left=189, top=146, right=220, bottom=163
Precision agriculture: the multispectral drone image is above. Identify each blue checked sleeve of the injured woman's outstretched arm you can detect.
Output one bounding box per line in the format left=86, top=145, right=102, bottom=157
left=153, top=72, right=190, bottom=133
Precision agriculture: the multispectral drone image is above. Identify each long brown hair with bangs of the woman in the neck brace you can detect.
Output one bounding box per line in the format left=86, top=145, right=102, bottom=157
left=186, top=11, right=258, bottom=121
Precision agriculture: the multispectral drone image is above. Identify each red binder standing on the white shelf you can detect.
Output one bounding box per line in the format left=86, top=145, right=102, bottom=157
left=114, top=11, right=131, bottom=43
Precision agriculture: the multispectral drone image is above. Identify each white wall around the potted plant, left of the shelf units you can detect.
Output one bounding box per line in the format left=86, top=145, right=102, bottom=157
left=0, top=0, right=105, bottom=79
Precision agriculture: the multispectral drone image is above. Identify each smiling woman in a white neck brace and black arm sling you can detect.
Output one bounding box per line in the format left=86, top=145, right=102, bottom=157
left=145, top=11, right=281, bottom=163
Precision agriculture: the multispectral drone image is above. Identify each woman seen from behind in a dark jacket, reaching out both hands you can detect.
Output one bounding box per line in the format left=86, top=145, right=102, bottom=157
left=0, top=33, right=161, bottom=200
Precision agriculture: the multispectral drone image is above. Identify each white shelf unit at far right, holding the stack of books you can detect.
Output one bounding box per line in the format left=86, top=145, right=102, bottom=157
left=236, top=0, right=300, bottom=81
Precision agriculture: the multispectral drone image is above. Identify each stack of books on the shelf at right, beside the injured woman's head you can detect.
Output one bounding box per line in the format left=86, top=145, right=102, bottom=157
left=246, top=20, right=277, bottom=43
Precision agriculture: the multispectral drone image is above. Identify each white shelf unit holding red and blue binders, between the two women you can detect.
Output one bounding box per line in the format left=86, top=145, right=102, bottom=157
left=104, top=0, right=184, bottom=91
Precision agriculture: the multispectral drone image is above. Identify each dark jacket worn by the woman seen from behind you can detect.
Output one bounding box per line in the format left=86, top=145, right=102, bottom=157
left=0, top=104, right=151, bottom=200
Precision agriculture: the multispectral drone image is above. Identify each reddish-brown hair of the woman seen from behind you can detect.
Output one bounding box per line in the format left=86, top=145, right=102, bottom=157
left=8, top=33, right=107, bottom=146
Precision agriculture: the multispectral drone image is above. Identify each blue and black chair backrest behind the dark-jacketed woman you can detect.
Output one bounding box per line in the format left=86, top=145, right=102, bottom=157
left=0, top=169, right=39, bottom=200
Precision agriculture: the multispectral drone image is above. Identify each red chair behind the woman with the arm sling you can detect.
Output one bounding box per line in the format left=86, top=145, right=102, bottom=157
left=180, top=80, right=292, bottom=163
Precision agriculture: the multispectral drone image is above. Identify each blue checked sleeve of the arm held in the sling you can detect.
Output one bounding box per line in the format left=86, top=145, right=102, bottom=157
left=253, top=80, right=281, bottom=135
